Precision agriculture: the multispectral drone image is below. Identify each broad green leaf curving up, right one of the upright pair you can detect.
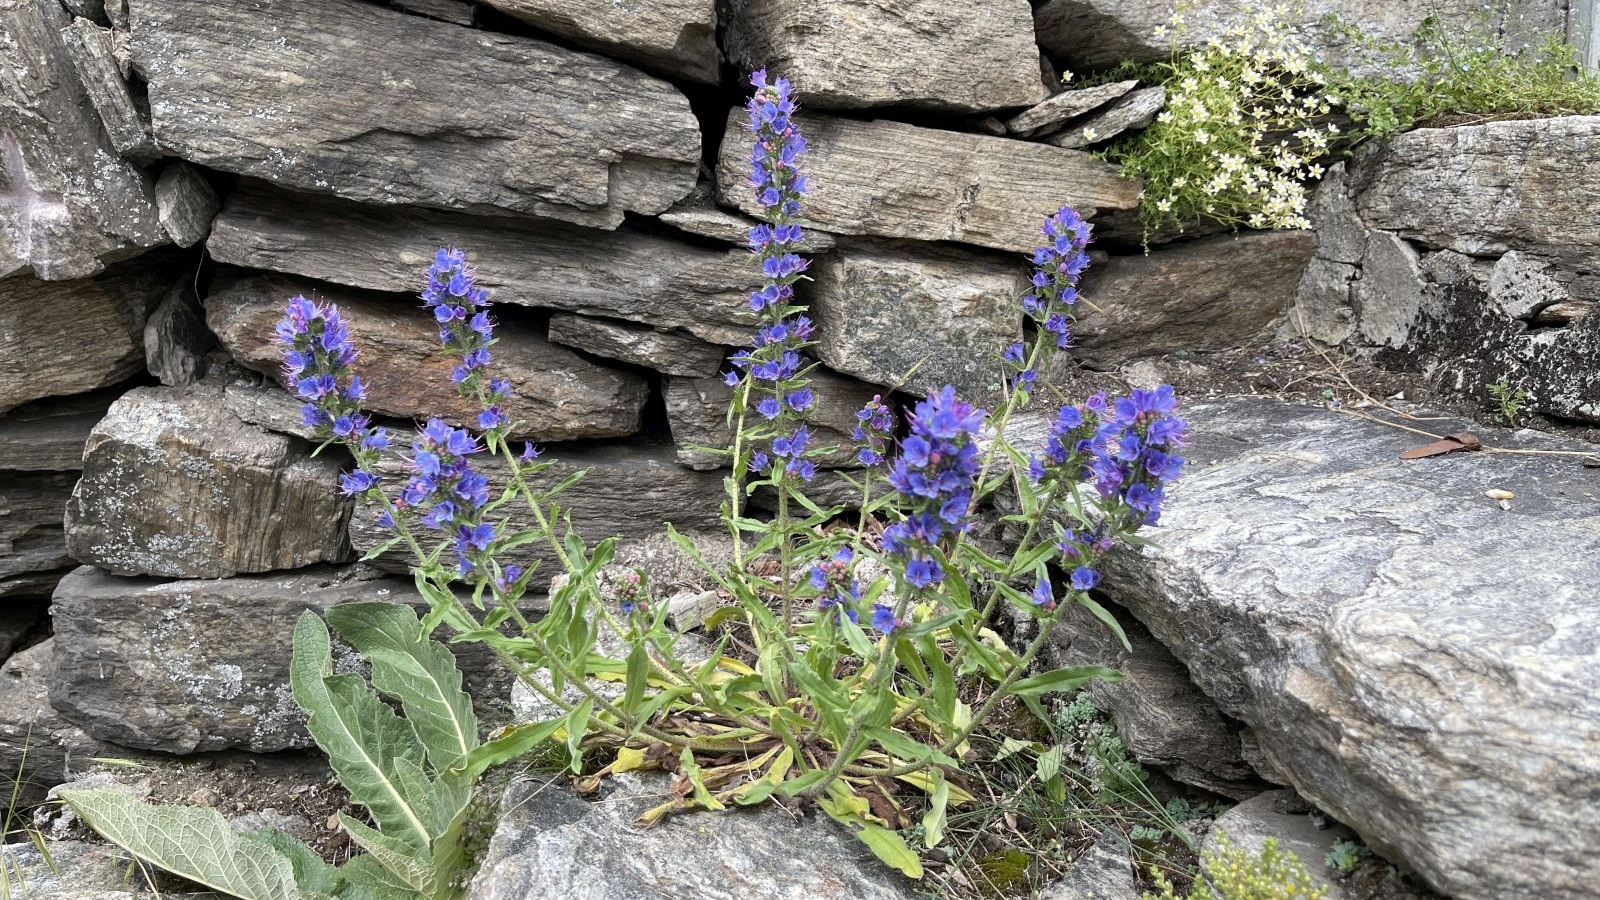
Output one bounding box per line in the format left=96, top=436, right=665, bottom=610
left=326, top=602, right=478, bottom=770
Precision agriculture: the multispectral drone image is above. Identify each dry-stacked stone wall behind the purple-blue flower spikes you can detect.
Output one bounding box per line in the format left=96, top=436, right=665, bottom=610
left=0, top=0, right=1600, bottom=890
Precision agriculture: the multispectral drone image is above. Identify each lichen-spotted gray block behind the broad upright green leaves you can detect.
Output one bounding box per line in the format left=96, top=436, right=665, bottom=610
left=50, top=565, right=506, bottom=754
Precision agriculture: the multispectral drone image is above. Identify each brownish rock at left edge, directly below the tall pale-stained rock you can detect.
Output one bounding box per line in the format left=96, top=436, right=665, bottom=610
left=0, top=248, right=173, bottom=412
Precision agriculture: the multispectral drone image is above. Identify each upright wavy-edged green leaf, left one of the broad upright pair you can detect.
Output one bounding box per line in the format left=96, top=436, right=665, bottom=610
left=290, top=610, right=432, bottom=847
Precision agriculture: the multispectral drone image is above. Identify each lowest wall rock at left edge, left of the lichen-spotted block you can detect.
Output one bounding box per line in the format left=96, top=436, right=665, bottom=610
left=0, top=639, right=107, bottom=807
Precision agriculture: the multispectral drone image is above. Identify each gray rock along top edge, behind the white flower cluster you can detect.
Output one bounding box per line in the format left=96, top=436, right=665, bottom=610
left=1034, top=0, right=1566, bottom=69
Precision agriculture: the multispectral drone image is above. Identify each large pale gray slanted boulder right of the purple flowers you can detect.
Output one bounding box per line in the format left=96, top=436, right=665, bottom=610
left=1104, top=399, right=1600, bottom=900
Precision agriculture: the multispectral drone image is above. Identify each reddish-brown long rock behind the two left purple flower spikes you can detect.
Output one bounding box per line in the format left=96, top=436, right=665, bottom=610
left=205, top=275, right=650, bottom=440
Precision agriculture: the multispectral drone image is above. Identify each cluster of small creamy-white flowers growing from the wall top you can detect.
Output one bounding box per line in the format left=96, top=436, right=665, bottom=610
left=1130, top=3, right=1339, bottom=229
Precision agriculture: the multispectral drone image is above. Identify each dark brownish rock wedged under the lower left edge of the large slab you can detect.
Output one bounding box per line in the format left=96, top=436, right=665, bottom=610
left=1040, top=607, right=1266, bottom=799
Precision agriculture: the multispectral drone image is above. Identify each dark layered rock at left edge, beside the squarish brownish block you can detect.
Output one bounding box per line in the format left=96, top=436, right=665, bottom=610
left=0, top=472, right=77, bottom=602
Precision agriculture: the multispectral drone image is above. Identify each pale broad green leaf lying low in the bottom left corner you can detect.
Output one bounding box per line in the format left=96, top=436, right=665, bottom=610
left=61, top=788, right=301, bottom=900
